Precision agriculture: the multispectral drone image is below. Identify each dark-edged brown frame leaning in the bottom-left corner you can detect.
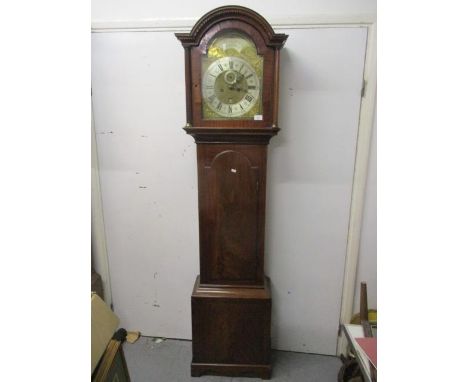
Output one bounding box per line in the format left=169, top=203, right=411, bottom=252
left=92, top=329, right=130, bottom=382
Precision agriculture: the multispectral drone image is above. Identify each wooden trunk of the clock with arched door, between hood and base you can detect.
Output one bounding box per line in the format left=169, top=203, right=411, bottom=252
left=198, top=145, right=266, bottom=284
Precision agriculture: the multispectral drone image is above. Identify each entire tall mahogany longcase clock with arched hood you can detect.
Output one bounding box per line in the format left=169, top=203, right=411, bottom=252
left=176, top=6, right=288, bottom=379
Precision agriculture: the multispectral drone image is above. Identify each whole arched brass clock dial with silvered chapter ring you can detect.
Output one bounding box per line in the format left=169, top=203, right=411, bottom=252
left=202, top=32, right=263, bottom=120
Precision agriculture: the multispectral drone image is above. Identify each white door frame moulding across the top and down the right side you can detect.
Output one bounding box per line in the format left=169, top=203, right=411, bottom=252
left=91, top=14, right=377, bottom=355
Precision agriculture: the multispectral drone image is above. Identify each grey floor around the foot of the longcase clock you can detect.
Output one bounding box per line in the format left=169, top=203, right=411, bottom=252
left=124, top=337, right=341, bottom=382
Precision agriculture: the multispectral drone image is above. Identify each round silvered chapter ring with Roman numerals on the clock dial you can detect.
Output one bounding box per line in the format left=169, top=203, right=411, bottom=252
left=202, top=56, right=261, bottom=118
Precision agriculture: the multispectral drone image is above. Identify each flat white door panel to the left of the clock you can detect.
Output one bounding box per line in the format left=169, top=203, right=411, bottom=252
left=92, top=33, right=199, bottom=338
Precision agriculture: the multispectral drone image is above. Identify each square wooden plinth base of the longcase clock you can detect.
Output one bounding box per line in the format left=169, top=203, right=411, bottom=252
left=191, top=277, right=271, bottom=379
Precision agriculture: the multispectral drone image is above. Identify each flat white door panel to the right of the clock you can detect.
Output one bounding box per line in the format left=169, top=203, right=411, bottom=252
left=266, top=28, right=366, bottom=354
